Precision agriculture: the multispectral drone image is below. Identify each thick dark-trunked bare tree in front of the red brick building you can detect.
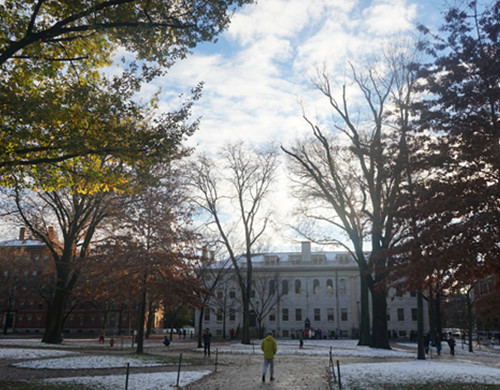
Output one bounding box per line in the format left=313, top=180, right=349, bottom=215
left=2, top=188, right=113, bottom=344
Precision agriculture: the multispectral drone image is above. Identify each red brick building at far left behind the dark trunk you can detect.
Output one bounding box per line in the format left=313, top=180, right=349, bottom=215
left=0, top=228, right=141, bottom=335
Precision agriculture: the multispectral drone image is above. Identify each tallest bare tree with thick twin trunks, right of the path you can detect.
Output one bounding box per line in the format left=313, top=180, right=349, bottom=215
left=283, top=46, right=418, bottom=348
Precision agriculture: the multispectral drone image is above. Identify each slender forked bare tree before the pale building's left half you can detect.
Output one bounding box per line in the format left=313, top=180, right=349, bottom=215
left=189, top=142, right=278, bottom=344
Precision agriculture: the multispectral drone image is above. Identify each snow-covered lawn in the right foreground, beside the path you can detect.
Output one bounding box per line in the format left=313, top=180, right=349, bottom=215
left=340, top=360, right=500, bottom=390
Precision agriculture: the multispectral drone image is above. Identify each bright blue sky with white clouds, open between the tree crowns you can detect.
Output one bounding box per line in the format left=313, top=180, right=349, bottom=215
left=143, top=0, right=453, bottom=250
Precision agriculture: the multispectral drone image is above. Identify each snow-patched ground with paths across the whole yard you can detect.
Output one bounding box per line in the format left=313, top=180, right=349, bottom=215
left=0, top=337, right=500, bottom=390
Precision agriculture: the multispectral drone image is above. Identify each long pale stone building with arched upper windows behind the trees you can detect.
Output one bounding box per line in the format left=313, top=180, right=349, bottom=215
left=195, top=242, right=428, bottom=338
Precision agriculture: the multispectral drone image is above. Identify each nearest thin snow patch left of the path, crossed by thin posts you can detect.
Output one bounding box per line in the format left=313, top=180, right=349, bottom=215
left=39, top=371, right=210, bottom=390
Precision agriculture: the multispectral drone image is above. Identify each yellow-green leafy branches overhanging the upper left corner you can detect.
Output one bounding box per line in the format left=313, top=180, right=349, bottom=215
left=0, top=0, right=251, bottom=192
